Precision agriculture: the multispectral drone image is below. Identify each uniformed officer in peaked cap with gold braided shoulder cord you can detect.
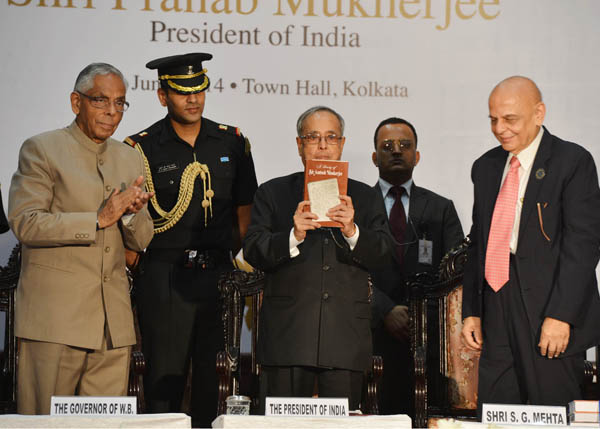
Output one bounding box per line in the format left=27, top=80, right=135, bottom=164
left=126, top=53, right=257, bottom=427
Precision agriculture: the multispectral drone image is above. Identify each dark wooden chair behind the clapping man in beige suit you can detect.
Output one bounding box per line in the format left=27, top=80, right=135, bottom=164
left=0, top=244, right=146, bottom=414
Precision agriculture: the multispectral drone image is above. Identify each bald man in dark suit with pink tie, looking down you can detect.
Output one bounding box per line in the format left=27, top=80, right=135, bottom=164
left=462, top=76, right=600, bottom=413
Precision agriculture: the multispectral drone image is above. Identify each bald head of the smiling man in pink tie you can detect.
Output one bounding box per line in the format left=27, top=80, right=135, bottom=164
left=489, top=76, right=546, bottom=155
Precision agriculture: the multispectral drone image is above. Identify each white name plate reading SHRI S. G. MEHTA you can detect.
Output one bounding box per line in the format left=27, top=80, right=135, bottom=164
left=481, top=404, right=567, bottom=426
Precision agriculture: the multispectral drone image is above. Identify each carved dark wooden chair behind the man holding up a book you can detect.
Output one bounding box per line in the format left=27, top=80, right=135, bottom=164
left=217, top=270, right=383, bottom=415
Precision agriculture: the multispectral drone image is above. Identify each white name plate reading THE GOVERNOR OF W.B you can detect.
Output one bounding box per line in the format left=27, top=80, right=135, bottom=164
left=50, top=396, right=137, bottom=416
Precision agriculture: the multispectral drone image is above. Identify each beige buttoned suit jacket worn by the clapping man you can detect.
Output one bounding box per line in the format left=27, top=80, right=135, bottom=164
left=8, top=122, right=153, bottom=350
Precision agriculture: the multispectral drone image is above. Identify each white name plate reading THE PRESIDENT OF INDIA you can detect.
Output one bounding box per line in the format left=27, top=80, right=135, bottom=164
left=265, top=397, right=348, bottom=417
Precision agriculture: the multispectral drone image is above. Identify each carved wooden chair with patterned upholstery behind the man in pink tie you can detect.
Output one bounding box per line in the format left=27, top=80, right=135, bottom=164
left=408, top=237, right=600, bottom=427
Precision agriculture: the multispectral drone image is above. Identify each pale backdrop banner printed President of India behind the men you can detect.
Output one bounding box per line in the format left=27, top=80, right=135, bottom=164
left=0, top=0, right=600, bottom=261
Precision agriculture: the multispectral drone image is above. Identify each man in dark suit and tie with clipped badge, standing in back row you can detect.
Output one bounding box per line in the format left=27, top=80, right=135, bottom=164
left=371, top=118, right=464, bottom=416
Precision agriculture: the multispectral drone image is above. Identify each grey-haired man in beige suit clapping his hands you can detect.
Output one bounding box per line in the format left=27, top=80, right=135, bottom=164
left=8, top=63, right=152, bottom=414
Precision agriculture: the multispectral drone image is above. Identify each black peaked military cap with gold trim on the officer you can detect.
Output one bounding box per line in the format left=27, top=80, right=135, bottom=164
left=146, top=52, right=212, bottom=94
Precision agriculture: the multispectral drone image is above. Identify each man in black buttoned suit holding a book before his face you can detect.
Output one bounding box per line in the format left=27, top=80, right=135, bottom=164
left=244, top=106, right=392, bottom=410
